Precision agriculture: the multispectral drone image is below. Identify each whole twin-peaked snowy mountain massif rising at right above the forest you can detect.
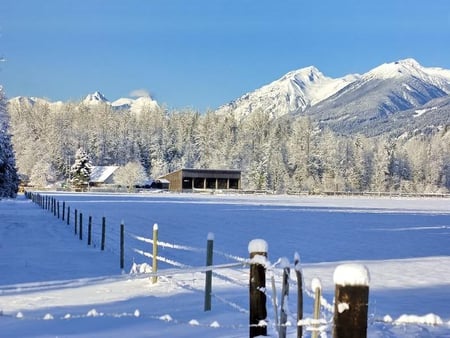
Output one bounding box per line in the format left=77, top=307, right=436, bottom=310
left=217, top=59, right=450, bottom=135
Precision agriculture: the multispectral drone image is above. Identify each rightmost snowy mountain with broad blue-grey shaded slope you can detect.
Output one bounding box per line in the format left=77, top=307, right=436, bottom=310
left=306, top=59, right=450, bottom=135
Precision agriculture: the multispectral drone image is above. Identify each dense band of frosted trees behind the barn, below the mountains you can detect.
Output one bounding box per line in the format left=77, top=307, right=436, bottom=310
left=8, top=97, right=450, bottom=193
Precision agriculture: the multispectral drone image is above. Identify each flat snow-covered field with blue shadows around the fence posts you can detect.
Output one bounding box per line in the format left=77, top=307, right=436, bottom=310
left=0, top=193, right=450, bottom=337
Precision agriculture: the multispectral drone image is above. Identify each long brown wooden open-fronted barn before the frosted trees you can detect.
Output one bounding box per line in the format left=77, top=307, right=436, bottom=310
left=160, top=168, right=241, bottom=191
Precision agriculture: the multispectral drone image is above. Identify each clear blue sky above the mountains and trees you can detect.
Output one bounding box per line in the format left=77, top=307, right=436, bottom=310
left=0, top=0, right=450, bottom=111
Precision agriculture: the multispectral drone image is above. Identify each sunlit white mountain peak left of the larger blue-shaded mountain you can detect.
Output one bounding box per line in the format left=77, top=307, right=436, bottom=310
left=217, top=66, right=359, bottom=119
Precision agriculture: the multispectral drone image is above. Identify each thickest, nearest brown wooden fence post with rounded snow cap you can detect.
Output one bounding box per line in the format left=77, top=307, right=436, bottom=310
left=333, top=264, right=370, bottom=338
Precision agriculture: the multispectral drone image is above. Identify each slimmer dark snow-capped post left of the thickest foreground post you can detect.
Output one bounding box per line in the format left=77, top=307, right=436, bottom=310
left=248, top=239, right=268, bottom=338
